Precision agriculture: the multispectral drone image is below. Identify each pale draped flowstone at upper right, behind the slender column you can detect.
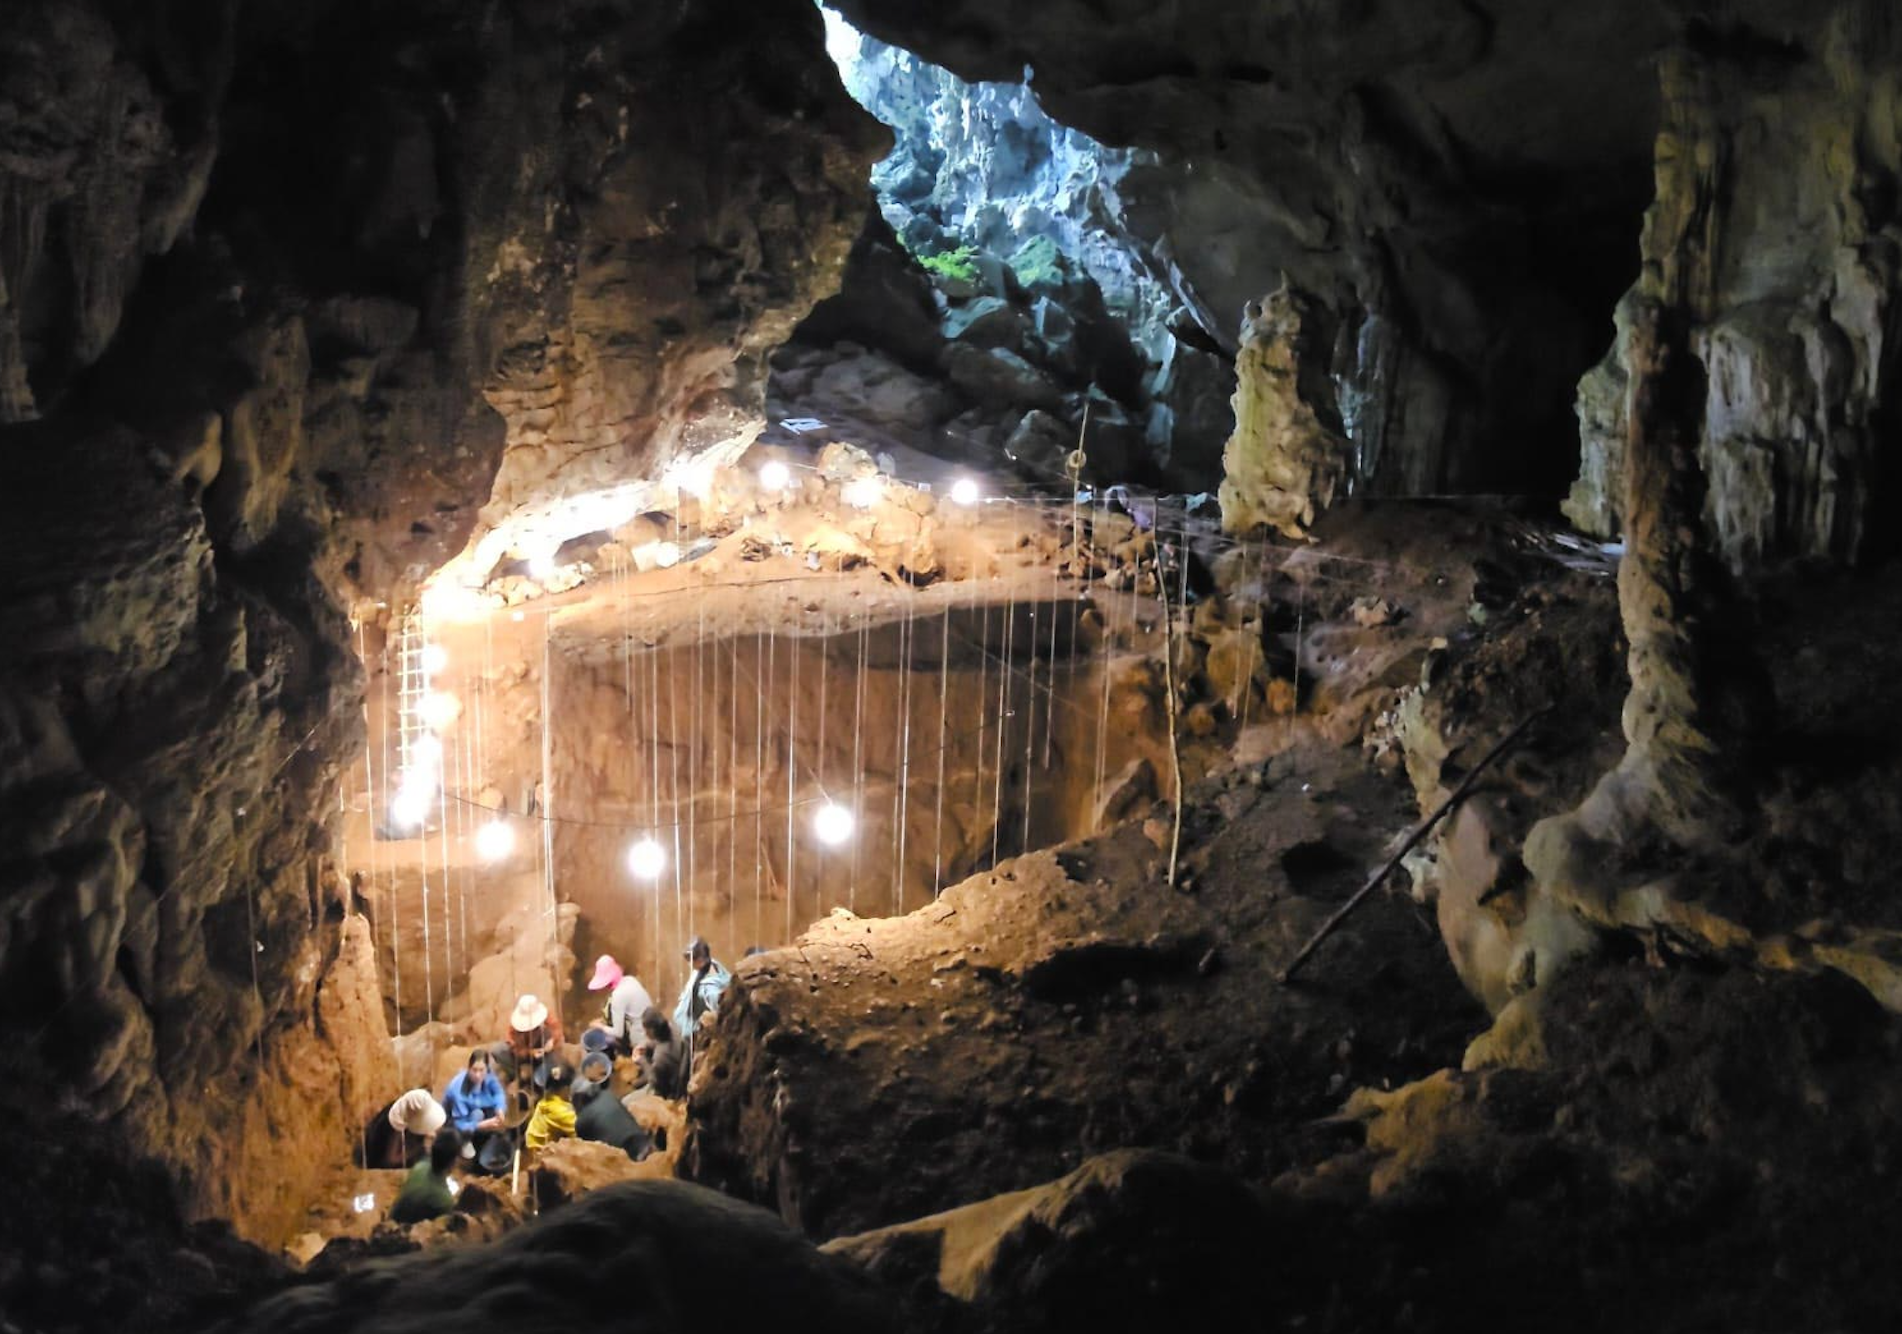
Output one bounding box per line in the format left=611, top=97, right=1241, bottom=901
left=1567, top=14, right=1902, bottom=569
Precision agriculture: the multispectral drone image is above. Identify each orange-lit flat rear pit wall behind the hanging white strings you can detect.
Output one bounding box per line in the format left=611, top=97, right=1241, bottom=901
left=550, top=586, right=1168, bottom=999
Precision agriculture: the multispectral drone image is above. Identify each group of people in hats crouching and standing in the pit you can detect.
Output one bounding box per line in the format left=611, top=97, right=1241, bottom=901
left=359, top=936, right=732, bottom=1224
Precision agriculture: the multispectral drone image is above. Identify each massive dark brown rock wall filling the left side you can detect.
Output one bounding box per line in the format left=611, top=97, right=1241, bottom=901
left=0, top=0, right=877, bottom=1239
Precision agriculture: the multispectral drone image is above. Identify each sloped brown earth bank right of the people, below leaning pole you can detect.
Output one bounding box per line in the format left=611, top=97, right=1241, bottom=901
left=685, top=748, right=1484, bottom=1237
